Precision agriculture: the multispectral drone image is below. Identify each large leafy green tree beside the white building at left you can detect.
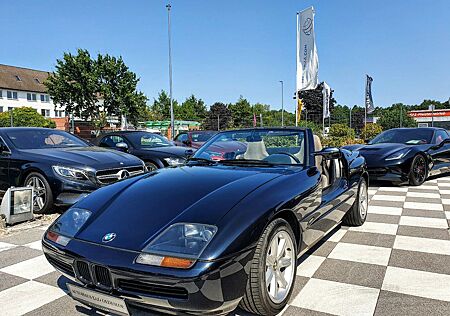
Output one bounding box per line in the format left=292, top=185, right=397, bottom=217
left=45, top=49, right=146, bottom=125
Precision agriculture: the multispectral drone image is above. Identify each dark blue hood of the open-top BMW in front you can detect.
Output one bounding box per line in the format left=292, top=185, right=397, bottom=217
left=76, top=166, right=282, bottom=251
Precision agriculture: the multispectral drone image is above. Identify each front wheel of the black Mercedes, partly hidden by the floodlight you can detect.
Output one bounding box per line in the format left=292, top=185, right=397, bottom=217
left=25, top=172, right=53, bottom=214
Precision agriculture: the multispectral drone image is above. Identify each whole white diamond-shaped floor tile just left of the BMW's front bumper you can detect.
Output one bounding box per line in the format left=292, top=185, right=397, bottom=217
left=0, top=255, right=55, bottom=279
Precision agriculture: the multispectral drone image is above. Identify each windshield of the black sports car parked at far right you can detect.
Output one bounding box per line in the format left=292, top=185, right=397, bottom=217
left=369, top=128, right=433, bottom=145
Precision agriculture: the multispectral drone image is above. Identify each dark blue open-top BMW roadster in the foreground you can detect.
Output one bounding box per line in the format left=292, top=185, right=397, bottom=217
left=42, top=128, right=368, bottom=315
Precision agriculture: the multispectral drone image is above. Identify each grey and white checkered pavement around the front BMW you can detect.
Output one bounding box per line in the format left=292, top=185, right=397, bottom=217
left=0, top=177, right=450, bottom=316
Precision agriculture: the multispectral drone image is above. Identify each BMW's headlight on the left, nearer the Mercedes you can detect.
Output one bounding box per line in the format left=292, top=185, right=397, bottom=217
left=46, top=207, right=92, bottom=246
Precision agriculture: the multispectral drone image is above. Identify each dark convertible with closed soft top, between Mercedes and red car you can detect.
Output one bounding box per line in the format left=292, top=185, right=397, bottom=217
left=96, top=131, right=194, bottom=171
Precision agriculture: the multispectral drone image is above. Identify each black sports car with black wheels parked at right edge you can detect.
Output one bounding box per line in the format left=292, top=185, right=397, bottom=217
left=344, top=127, right=450, bottom=185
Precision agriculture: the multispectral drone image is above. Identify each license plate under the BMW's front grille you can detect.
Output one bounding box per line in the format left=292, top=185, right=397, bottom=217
left=67, top=284, right=129, bottom=315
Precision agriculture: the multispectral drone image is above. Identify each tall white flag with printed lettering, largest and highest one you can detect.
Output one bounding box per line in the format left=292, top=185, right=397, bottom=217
left=297, top=7, right=319, bottom=92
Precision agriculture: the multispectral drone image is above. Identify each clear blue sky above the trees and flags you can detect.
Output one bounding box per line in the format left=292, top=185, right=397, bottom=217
left=0, top=0, right=450, bottom=110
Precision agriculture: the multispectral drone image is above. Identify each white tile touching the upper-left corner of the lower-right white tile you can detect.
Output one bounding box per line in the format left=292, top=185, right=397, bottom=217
left=328, top=243, right=391, bottom=266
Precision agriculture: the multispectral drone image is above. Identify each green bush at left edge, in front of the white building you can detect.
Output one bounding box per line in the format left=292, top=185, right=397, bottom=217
left=0, top=107, right=56, bottom=128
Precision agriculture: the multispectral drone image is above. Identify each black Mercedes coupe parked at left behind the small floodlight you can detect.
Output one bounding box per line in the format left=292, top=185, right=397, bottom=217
left=0, top=127, right=145, bottom=213
